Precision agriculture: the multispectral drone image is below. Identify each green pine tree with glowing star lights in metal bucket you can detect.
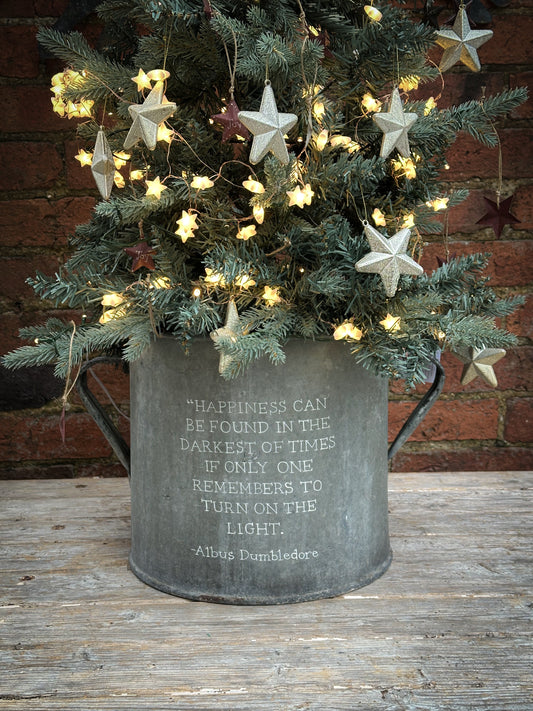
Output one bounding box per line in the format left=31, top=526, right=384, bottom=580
left=4, top=0, right=525, bottom=383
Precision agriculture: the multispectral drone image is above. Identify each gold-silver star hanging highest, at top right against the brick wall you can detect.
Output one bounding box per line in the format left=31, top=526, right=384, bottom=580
left=436, top=6, right=492, bottom=72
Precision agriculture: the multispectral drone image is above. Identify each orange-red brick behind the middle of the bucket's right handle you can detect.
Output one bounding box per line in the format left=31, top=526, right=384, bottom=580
left=389, top=399, right=498, bottom=442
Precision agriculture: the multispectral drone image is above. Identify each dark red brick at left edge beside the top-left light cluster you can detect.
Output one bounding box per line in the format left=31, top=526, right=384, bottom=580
left=2, top=86, right=75, bottom=133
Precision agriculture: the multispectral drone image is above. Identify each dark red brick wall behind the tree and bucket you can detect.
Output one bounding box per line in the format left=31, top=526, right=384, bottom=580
left=0, top=0, right=533, bottom=478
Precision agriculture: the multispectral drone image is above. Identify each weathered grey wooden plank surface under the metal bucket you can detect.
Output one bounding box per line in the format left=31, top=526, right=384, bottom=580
left=0, top=472, right=533, bottom=711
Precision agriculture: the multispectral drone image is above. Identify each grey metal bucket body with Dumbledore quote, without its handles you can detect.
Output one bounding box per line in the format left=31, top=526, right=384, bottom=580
left=130, top=338, right=390, bottom=604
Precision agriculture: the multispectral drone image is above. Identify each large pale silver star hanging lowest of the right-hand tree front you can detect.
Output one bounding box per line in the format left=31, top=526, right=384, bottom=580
left=355, top=221, right=424, bottom=297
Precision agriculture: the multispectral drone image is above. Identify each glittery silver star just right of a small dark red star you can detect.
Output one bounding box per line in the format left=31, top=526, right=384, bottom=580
left=239, top=81, right=298, bottom=165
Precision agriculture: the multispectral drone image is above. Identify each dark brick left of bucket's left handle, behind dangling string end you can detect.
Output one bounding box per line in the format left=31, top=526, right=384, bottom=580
left=0, top=412, right=111, bottom=462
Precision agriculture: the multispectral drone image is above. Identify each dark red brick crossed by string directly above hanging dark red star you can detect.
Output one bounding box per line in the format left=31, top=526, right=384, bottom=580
left=443, top=128, right=533, bottom=180
